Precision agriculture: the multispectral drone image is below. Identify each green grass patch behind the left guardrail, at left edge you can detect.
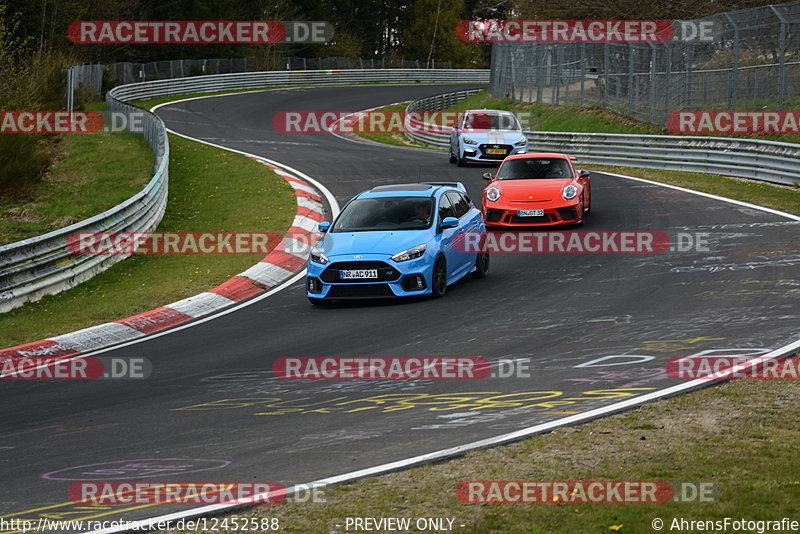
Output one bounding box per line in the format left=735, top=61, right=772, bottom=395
left=0, top=133, right=153, bottom=244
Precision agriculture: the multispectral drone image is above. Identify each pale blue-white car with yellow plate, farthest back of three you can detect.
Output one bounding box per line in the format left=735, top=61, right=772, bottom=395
left=450, top=109, right=528, bottom=167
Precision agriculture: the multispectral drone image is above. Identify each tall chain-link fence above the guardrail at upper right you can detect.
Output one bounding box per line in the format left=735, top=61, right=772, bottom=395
left=491, top=2, right=800, bottom=125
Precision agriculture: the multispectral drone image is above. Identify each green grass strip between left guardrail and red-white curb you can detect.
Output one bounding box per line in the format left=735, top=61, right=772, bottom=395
left=0, top=135, right=295, bottom=347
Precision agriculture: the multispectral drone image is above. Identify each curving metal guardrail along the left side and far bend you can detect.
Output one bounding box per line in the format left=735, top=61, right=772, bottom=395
left=0, top=69, right=489, bottom=313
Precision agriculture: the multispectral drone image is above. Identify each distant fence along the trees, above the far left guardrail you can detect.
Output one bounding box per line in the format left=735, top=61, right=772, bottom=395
left=71, top=57, right=452, bottom=101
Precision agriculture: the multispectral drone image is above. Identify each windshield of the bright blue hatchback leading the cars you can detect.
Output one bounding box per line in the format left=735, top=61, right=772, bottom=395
left=331, top=197, right=433, bottom=232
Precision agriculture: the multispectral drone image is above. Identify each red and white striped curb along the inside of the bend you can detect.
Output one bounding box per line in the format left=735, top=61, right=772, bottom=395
left=0, top=159, right=325, bottom=358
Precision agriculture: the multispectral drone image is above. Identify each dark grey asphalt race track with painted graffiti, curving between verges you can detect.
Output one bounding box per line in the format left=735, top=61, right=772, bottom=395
left=0, top=85, right=800, bottom=519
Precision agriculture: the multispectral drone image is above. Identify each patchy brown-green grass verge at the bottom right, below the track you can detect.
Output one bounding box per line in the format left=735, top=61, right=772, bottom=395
left=203, top=380, right=800, bottom=534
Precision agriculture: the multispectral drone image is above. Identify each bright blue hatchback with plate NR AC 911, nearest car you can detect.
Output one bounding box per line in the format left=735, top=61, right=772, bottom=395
left=306, top=182, right=489, bottom=304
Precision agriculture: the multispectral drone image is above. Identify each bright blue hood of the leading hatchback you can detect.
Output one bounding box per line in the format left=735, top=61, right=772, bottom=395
left=320, top=229, right=430, bottom=259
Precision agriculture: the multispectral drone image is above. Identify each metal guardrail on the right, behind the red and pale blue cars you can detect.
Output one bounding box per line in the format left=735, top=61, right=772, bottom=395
left=406, top=91, right=800, bottom=185
